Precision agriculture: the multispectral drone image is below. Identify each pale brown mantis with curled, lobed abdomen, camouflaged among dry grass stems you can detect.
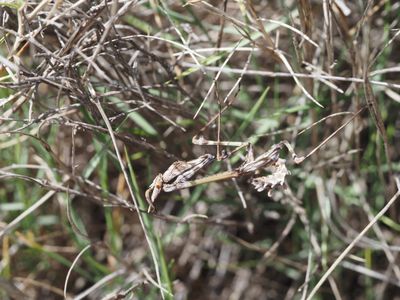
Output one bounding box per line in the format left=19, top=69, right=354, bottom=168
left=145, top=136, right=304, bottom=212
